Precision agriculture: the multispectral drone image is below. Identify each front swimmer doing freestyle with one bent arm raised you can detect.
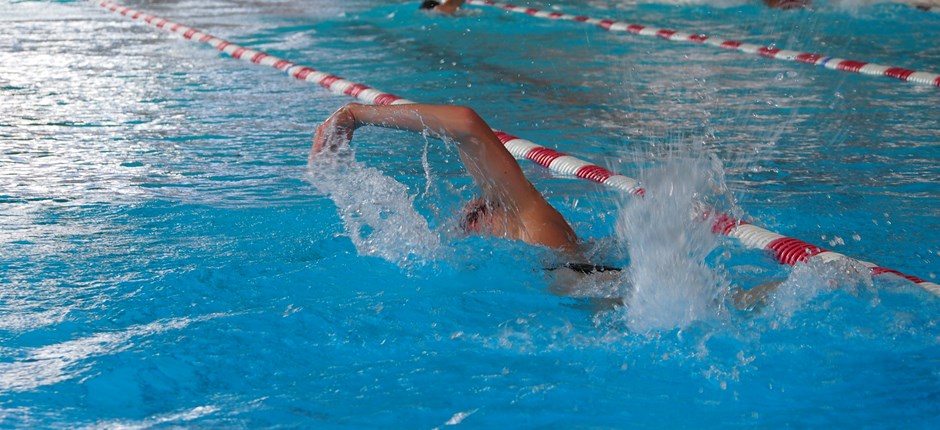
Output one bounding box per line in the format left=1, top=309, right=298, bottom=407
left=310, top=103, right=779, bottom=310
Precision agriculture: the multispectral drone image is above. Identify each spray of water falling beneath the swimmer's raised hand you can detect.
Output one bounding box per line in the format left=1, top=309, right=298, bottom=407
left=307, top=146, right=442, bottom=268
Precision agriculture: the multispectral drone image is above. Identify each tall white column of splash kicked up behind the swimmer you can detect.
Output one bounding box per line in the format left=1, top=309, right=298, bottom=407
left=616, top=145, right=729, bottom=332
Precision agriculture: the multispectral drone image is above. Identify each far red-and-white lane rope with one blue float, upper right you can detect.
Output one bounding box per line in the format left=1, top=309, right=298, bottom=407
left=466, top=0, right=940, bottom=87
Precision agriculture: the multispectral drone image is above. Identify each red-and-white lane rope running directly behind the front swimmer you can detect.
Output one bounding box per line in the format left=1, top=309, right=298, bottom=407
left=92, top=0, right=940, bottom=296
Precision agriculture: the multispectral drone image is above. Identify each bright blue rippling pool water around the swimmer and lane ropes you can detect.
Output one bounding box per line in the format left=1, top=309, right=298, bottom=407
left=0, top=0, right=940, bottom=428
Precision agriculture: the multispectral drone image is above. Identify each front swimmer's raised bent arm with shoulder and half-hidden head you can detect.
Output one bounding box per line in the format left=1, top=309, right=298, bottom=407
left=310, top=103, right=579, bottom=253
